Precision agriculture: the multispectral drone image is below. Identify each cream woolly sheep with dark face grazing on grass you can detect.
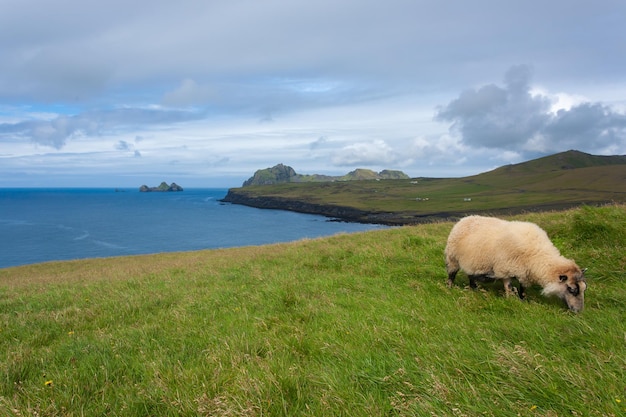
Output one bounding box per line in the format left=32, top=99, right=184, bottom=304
left=444, top=216, right=587, bottom=312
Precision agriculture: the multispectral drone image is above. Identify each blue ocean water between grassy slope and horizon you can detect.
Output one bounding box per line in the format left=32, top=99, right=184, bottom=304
left=0, top=188, right=384, bottom=268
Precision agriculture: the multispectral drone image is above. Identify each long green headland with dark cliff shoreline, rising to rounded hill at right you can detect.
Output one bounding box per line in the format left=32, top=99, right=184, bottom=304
left=224, top=151, right=626, bottom=224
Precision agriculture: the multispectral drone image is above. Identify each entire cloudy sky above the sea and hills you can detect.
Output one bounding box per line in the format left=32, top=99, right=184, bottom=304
left=0, top=0, right=626, bottom=187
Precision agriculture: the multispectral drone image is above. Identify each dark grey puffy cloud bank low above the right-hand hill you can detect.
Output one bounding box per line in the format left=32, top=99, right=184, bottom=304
left=436, top=65, right=626, bottom=153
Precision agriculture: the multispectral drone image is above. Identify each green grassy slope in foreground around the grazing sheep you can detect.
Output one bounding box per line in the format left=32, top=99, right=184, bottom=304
left=0, top=205, right=626, bottom=416
